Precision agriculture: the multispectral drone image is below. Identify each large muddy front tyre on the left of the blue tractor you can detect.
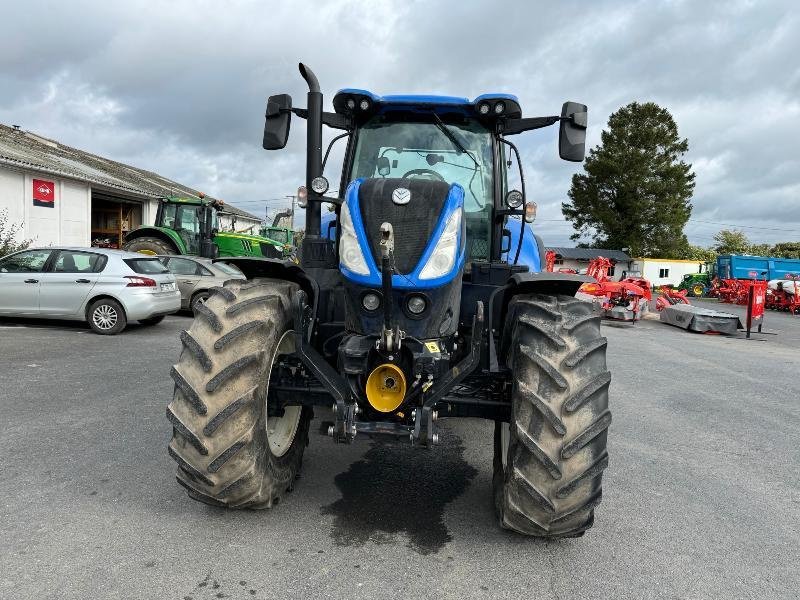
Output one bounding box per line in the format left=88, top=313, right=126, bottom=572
left=167, top=279, right=311, bottom=508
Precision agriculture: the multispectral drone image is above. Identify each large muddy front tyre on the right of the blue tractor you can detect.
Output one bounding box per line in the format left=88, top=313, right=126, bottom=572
left=494, top=294, right=611, bottom=538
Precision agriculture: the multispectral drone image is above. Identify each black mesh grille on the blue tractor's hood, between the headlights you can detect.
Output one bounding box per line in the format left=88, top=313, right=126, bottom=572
left=358, top=179, right=450, bottom=275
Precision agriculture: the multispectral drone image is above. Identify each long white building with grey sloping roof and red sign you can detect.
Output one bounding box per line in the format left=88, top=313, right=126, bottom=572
left=0, top=124, right=261, bottom=247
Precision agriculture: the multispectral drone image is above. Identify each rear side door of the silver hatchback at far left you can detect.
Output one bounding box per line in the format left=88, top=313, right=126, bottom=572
left=39, top=250, right=107, bottom=317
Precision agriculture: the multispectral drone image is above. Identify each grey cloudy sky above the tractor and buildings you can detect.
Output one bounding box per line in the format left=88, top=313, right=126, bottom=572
left=0, top=0, right=800, bottom=245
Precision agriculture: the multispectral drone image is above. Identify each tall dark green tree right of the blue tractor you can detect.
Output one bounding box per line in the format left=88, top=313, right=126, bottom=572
left=561, top=102, right=694, bottom=256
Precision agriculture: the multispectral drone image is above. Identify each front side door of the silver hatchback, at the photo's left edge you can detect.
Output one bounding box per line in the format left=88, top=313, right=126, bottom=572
left=0, top=250, right=53, bottom=316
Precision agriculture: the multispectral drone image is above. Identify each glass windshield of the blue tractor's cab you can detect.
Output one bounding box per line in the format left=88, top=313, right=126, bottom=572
left=350, top=117, right=493, bottom=260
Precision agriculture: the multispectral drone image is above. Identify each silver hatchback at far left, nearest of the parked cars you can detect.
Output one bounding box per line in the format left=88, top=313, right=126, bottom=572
left=0, top=248, right=181, bottom=335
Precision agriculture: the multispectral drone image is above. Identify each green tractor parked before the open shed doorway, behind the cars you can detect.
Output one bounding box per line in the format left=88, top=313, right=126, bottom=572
left=123, top=196, right=292, bottom=258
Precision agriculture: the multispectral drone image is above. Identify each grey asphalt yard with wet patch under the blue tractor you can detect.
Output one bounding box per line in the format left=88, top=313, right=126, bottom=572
left=0, top=306, right=800, bottom=600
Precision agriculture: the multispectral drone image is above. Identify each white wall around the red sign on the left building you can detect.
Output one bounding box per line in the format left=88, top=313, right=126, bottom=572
left=0, top=167, right=91, bottom=246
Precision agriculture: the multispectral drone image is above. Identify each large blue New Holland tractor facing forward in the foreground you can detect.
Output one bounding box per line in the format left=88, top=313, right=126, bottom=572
left=167, top=64, right=611, bottom=538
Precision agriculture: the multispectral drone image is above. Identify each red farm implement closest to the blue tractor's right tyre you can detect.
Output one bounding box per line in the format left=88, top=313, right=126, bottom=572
left=580, top=256, right=653, bottom=322
